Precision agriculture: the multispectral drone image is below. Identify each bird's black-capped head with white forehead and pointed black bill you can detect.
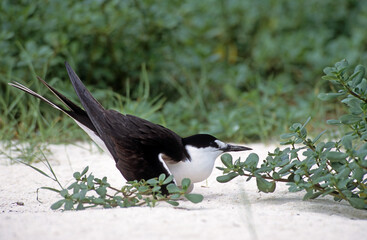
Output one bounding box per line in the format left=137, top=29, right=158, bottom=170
left=183, top=134, right=252, bottom=161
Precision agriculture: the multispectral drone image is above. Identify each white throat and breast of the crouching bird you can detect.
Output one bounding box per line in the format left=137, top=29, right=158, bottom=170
left=167, top=145, right=222, bottom=185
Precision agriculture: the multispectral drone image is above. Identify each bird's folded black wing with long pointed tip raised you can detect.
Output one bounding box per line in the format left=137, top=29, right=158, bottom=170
left=65, top=63, right=186, bottom=181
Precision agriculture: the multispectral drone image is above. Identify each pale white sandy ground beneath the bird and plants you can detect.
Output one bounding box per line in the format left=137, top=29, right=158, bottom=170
left=0, top=144, right=367, bottom=240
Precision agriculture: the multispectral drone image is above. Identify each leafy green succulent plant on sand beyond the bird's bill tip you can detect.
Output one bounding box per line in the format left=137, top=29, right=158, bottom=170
left=217, top=60, right=367, bottom=209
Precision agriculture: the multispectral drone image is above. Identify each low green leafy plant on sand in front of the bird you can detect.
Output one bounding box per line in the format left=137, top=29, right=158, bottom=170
left=18, top=152, right=203, bottom=210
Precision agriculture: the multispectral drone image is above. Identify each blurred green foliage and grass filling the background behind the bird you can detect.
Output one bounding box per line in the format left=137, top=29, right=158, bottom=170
left=0, top=0, right=367, bottom=142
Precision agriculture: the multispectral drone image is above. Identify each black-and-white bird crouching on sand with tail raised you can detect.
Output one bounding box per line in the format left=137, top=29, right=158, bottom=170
left=9, top=62, right=252, bottom=192
